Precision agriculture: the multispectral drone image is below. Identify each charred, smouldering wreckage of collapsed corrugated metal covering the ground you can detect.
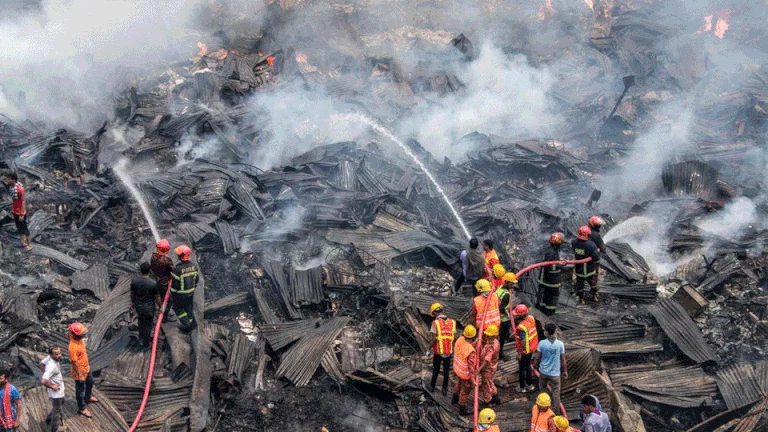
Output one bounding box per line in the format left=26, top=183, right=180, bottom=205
left=0, top=1, right=768, bottom=432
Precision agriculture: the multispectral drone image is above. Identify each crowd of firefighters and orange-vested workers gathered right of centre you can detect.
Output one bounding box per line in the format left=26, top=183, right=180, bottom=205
left=430, top=216, right=612, bottom=432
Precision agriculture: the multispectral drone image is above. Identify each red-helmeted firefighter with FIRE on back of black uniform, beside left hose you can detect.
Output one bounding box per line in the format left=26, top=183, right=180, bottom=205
left=171, top=245, right=200, bottom=332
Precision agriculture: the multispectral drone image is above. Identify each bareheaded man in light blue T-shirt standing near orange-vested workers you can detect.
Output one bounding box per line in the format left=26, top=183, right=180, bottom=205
left=533, top=323, right=568, bottom=415
